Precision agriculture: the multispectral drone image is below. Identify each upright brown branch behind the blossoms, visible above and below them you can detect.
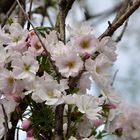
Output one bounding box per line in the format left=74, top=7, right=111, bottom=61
left=55, top=0, right=74, bottom=140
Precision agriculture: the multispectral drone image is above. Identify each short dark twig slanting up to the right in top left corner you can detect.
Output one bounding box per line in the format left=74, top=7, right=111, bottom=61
left=1, top=1, right=16, bottom=27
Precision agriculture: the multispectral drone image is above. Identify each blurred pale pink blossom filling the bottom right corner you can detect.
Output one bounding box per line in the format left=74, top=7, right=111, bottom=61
left=108, top=102, right=140, bottom=140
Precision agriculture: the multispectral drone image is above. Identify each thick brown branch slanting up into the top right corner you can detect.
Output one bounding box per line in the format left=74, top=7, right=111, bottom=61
left=99, top=0, right=140, bottom=40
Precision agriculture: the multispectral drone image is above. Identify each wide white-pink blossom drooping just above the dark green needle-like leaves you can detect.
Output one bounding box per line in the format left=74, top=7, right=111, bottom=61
left=25, top=73, right=68, bottom=105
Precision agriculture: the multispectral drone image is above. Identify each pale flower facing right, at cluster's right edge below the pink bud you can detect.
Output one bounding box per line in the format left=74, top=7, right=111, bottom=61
left=85, top=54, right=113, bottom=91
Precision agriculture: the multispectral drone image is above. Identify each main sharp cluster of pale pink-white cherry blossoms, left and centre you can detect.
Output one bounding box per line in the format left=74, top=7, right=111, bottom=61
left=0, top=23, right=132, bottom=140
